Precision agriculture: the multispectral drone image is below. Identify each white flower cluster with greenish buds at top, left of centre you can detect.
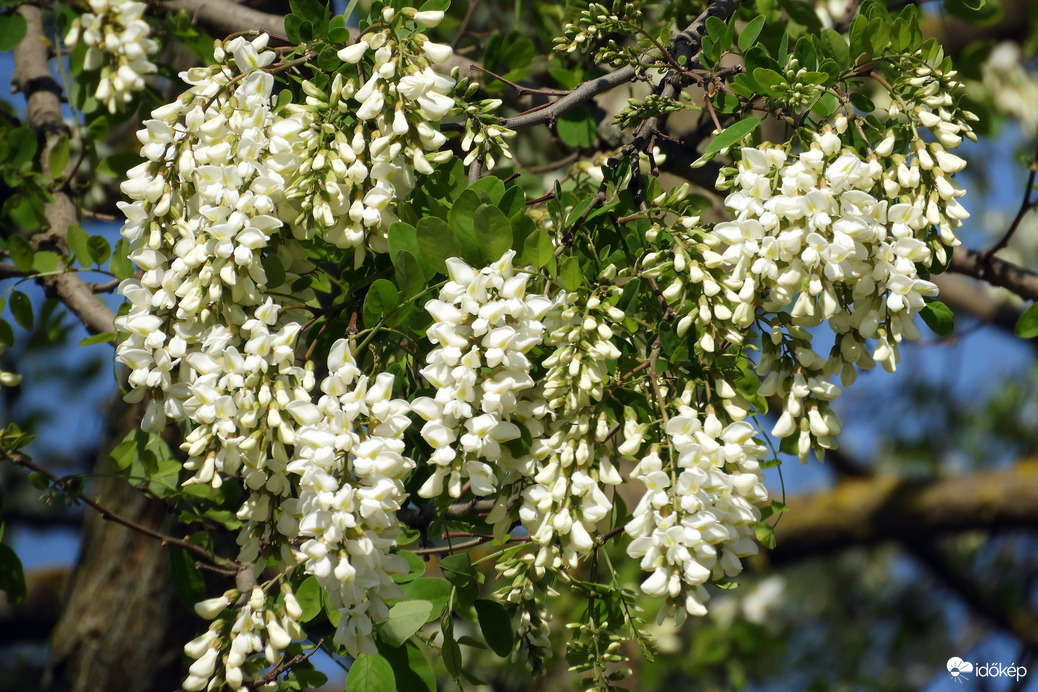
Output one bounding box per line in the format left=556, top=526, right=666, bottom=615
left=286, top=7, right=455, bottom=259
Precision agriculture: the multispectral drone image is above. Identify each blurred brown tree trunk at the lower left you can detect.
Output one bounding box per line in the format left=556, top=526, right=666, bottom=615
left=44, top=403, right=197, bottom=692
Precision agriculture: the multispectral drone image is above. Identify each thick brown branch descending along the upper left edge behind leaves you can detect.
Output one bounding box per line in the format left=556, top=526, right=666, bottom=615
left=12, top=5, right=115, bottom=334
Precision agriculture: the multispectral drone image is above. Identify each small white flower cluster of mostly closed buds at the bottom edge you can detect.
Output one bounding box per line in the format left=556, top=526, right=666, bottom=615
left=182, top=584, right=303, bottom=692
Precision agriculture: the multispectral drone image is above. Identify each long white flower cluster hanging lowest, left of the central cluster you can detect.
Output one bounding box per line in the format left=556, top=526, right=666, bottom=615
left=278, top=339, right=414, bottom=656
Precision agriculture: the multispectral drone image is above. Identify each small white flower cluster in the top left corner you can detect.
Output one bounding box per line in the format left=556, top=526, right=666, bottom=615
left=65, top=0, right=159, bottom=113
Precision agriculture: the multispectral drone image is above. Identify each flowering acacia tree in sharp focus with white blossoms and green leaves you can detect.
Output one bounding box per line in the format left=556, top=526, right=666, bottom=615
left=0, top=0, right=1038, bottom=691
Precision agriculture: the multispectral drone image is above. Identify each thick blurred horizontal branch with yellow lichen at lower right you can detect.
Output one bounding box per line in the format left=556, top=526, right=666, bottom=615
left=761, top=460, right=1038, bottom=563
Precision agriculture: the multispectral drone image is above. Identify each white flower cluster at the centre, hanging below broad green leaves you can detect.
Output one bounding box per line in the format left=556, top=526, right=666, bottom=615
left=411, top=250, right=552, bottom=497
